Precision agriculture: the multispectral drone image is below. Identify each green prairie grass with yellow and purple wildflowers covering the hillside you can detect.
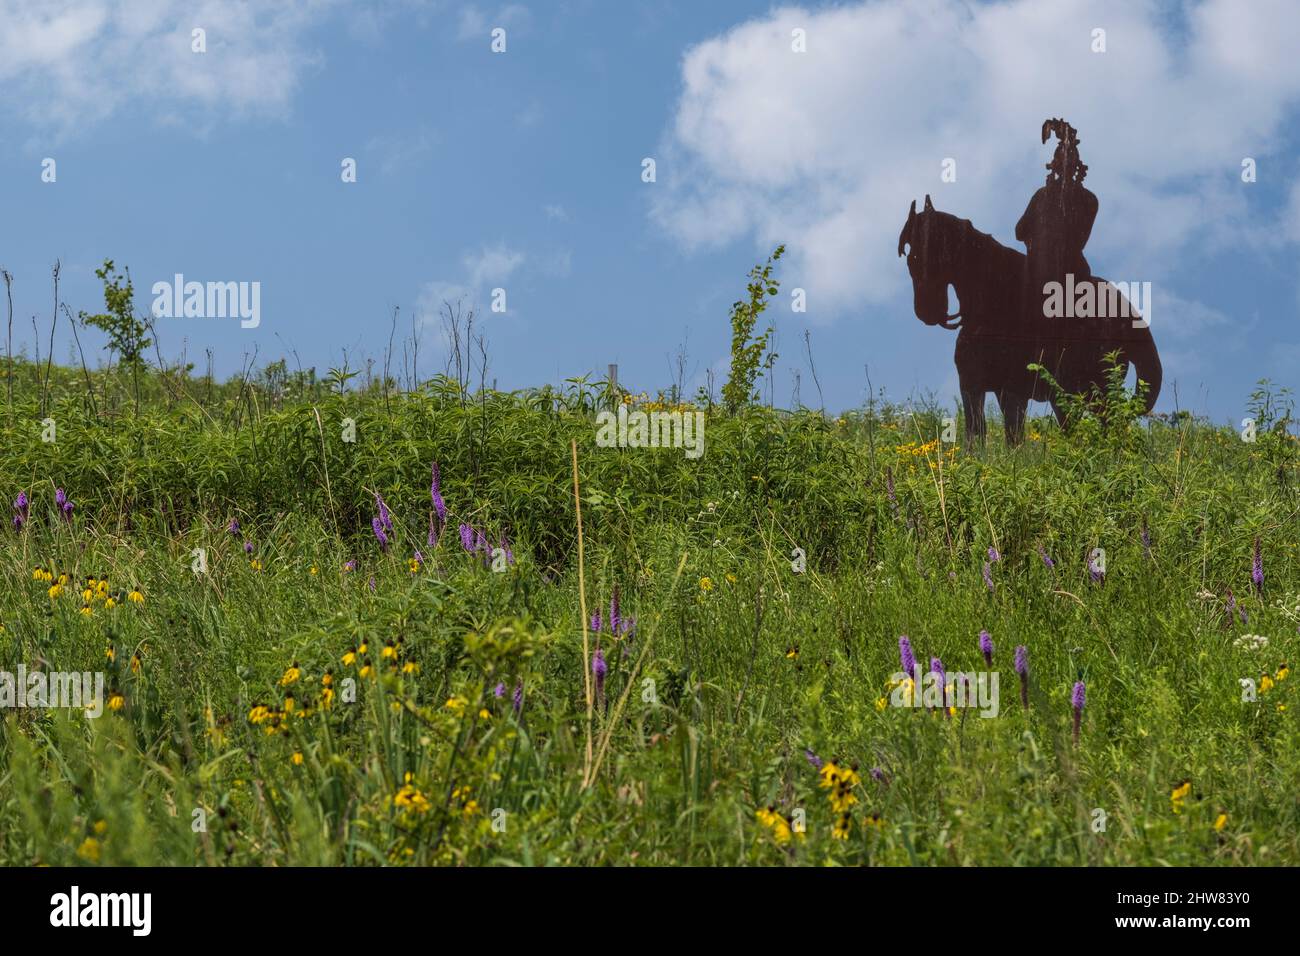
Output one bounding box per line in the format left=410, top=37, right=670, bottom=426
left=0, top=363, right=1300, bottom=865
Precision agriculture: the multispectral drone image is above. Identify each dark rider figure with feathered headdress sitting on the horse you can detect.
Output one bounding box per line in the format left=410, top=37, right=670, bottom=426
left=1015, top=120, right=1097, bottom=317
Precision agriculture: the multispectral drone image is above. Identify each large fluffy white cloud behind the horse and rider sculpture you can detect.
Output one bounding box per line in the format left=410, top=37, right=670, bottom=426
left=651, top=0, right=1300, bottom=321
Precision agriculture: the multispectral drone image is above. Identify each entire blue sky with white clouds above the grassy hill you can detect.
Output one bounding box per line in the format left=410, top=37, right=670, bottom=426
left=0, top=0, right=1300, bottom=420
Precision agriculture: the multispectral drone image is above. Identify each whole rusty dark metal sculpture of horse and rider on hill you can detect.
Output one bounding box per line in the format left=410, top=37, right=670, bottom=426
left=898, top=120, right=1162, bottom=445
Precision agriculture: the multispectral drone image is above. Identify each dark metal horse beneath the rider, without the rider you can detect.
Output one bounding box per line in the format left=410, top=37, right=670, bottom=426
left=898, top=195, right=1161, bottom=445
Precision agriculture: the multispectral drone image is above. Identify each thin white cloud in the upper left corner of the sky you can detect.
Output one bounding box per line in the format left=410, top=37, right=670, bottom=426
left=0, top=0, right=338, bottom=135
